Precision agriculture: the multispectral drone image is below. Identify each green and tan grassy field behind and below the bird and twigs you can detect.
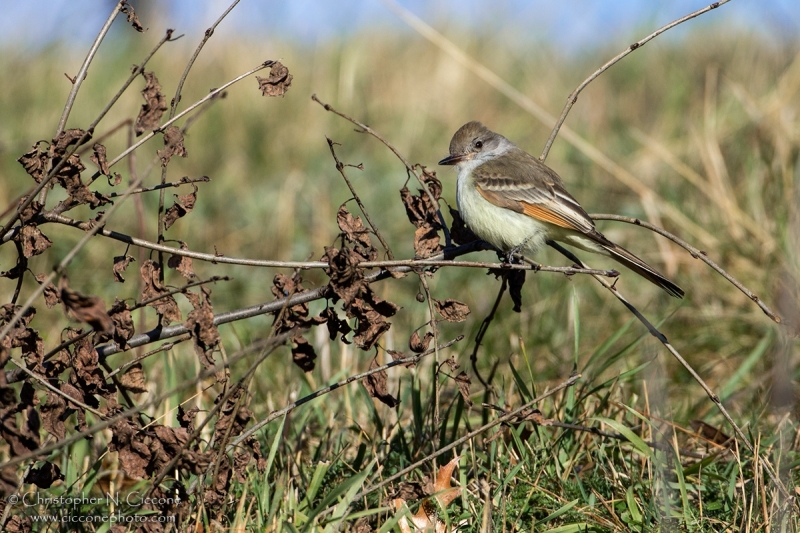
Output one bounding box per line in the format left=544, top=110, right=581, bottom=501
left=0, top=9, right=800, bottom=532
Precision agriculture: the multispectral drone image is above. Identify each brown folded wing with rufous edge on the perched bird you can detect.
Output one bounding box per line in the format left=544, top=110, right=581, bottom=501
left=473, top=149, right=605, bottom=236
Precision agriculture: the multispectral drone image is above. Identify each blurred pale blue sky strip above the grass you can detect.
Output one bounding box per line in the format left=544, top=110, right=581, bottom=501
left=0, top=0, right=800, bottom=51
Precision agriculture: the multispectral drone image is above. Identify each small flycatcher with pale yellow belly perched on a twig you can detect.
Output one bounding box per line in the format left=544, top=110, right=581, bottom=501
left=439, top=122, right=684, bottom=298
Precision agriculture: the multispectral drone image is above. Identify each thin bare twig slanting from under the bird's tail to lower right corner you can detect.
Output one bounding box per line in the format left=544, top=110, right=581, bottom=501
left=547, top=241, right=790, bottom=500
